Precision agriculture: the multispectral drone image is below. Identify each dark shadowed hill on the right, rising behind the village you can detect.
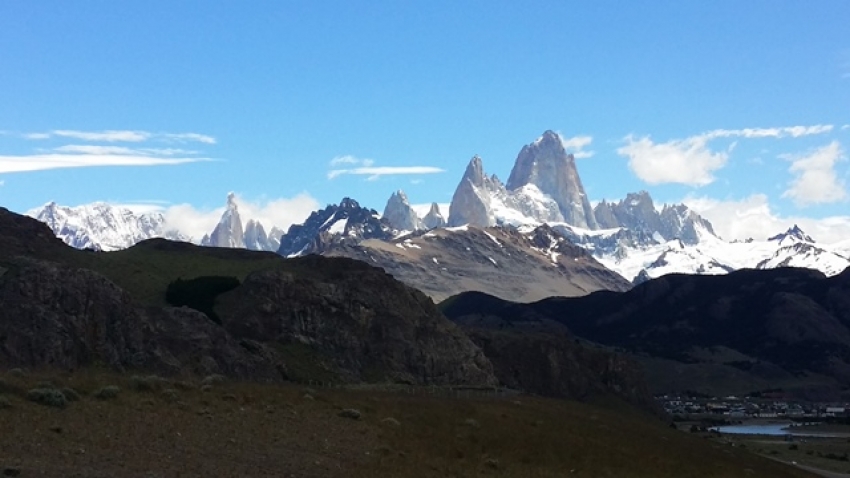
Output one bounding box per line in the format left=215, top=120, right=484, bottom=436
left=442, top=268, right=850, bottom=398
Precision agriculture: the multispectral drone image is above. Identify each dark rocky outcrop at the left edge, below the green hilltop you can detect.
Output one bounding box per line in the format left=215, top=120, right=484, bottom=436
left=0, top=257, right=285, bottom=380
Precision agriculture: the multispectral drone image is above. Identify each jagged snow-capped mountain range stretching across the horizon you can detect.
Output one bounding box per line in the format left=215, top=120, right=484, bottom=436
left=28, top=131, right=850, bottom=293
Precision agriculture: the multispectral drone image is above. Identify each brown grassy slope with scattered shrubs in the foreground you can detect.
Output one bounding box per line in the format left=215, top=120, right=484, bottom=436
left=0, top=371, right=810, bottom=478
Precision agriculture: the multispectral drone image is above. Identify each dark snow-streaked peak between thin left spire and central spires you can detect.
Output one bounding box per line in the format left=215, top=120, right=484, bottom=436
left=277, top=198, right=397, bottom=257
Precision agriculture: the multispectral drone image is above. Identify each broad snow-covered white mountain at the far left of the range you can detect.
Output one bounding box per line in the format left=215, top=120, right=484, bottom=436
left=26, top=202, right=186, bottom=251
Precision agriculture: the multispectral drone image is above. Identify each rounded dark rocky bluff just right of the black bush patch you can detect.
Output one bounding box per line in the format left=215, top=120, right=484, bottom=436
left=217, top=255, right=495, bottom=385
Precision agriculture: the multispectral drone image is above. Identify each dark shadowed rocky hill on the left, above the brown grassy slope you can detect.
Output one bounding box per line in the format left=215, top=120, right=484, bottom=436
left=0, top=205, right=652, bottom=409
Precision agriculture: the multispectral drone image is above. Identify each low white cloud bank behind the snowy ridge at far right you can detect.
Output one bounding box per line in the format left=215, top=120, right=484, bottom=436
left=682, top=194, right=850, bottom=244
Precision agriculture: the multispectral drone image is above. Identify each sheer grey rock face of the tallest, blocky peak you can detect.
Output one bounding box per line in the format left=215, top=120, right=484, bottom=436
left=507, top=131, right=597, bottom=229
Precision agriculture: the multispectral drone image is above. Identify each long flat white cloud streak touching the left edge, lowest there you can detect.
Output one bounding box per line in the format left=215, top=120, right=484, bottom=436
left=0, top=153, right=210, bottom=173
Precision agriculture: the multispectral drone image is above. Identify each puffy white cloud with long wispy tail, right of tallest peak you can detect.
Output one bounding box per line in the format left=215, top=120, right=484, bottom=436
left=617, top=125, right=834, bottom=186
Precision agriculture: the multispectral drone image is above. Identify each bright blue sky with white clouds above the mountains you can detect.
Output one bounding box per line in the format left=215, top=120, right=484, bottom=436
left=0, top=0, right=850, bottom=243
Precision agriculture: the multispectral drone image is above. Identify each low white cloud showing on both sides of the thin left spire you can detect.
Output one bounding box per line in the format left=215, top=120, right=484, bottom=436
left=161, top=193, right=320, bottom=242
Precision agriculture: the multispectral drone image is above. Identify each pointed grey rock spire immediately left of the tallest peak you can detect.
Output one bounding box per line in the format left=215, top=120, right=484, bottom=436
left=448, top=155, right=495, bottom=227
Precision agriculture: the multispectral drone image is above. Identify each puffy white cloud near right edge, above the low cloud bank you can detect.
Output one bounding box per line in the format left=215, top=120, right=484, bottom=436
left=782, top=141, right=847, bottom=206
